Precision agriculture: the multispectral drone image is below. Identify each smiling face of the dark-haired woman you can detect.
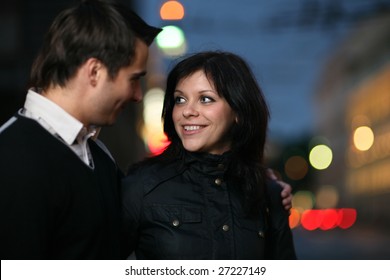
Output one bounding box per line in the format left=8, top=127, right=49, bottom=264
left=172, top=70, right=236, bottom=154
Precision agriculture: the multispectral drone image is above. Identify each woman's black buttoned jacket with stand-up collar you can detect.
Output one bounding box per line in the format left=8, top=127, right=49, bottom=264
left=122, top=154, right=296, bottom=259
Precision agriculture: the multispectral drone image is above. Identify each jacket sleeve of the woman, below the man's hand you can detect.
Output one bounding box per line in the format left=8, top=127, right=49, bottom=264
left=267, top=181, right=297, bottom=260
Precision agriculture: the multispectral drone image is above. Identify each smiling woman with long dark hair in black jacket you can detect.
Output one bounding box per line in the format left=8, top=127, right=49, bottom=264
left=123, top=52, right=296, bottom=259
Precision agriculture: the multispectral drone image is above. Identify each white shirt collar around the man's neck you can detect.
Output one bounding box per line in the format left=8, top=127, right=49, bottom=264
left=24, top=89, right=95, bottom=145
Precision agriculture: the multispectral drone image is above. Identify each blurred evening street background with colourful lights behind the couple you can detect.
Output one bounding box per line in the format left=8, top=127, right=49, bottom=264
left=0, top=0, right=390, bottom=259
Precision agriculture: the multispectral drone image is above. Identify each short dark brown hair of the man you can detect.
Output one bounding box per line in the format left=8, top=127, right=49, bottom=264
left=30, top=0, right=161, bottom=89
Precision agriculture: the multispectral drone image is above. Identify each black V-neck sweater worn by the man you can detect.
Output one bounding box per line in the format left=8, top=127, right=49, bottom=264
left=0, top=115, right=120, bottom=259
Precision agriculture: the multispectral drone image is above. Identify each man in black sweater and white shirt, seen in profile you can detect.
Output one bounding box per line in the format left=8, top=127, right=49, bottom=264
left=0, top=0, right=161, bottom=259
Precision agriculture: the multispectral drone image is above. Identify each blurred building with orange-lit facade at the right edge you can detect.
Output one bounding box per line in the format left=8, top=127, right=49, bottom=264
left=316, top=11, right=390, bottom=226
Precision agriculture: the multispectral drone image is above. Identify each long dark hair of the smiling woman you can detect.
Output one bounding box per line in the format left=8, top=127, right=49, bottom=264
left=160, top=51, right=269, bottom=214
